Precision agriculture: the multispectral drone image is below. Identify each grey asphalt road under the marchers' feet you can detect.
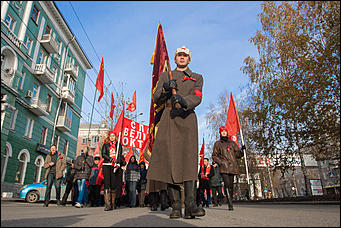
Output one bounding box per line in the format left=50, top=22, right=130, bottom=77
left=1, top=200, right=340, bottom=227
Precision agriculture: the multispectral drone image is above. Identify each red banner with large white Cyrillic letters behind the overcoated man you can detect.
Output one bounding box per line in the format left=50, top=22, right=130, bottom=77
left=121, top=117, right=149, bottom=149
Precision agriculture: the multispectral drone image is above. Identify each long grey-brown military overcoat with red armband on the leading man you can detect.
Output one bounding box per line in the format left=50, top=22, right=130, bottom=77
left=147, top=68, right=203, bottom=184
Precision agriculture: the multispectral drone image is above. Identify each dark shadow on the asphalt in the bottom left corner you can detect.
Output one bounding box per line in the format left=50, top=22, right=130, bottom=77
left=1, top=214, right=87, bottom=227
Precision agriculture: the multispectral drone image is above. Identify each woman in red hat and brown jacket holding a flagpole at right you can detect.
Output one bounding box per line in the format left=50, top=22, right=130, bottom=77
left=212, top=126, right=245, bottom=211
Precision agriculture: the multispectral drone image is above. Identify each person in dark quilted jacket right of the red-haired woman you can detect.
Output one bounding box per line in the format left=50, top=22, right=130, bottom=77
left=125, top=155, right=140, bottom=207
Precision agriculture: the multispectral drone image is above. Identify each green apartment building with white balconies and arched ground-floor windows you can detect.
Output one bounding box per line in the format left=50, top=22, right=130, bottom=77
left=1, top=1, right=92, bottom=191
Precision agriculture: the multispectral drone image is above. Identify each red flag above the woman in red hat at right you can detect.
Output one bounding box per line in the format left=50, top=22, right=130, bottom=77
left=226, top=92, right=240, bottom=145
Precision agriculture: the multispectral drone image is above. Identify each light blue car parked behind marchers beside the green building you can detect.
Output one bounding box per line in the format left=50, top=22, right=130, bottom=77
left=18, top=180, right=72, bottom=203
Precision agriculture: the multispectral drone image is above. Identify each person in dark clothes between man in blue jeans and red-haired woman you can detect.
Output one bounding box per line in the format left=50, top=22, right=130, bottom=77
left=89, top=154, right=101, bottom=207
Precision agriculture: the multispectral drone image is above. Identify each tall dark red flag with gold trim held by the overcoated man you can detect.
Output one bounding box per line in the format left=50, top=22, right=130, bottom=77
left=145, top=24, right=169, bottom=159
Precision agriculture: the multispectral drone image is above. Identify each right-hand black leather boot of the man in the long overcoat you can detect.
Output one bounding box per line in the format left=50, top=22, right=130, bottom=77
left=184, top=181, right=205, bottom=219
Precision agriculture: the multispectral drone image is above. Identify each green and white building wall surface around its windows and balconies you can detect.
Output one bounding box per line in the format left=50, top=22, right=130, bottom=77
left=1, top=1, right=92, bottom=191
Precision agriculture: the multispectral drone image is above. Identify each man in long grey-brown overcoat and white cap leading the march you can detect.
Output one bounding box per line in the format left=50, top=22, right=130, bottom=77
left=147, top=46, right=205, bottom=219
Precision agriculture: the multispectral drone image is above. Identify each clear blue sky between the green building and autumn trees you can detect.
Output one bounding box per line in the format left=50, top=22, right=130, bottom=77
left=55, top=1, right=261, bottom=144
